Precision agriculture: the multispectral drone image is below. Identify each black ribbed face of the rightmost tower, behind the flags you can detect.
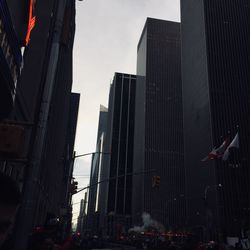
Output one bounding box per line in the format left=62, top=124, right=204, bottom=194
left=204, top=0, right=250, bottom=234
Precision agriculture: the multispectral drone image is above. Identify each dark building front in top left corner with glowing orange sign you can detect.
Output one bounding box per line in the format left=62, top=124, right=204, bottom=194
left=0, top=0, right=32, bottom=119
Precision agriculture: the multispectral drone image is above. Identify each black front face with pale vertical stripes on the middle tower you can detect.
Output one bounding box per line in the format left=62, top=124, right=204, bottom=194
left=107, top=73, right=136, bottom=215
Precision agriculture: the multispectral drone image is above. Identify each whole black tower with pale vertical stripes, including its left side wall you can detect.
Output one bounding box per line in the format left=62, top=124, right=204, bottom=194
left=99, top=73, right=136, bottom=237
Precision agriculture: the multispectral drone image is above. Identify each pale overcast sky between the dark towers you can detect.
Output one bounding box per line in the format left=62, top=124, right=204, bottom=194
left=70, top=0, right=180, bottom=223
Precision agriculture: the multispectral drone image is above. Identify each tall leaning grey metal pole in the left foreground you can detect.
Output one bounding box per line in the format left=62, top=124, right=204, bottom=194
left=15, top=0, right=67, bottom=250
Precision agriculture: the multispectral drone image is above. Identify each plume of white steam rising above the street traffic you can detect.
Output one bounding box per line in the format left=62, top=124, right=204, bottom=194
left=129, top=212, right=165, bottom=233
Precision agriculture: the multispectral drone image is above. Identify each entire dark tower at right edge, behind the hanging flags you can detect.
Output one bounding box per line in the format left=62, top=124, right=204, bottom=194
left=181, top=0, right=250, bottom=238
